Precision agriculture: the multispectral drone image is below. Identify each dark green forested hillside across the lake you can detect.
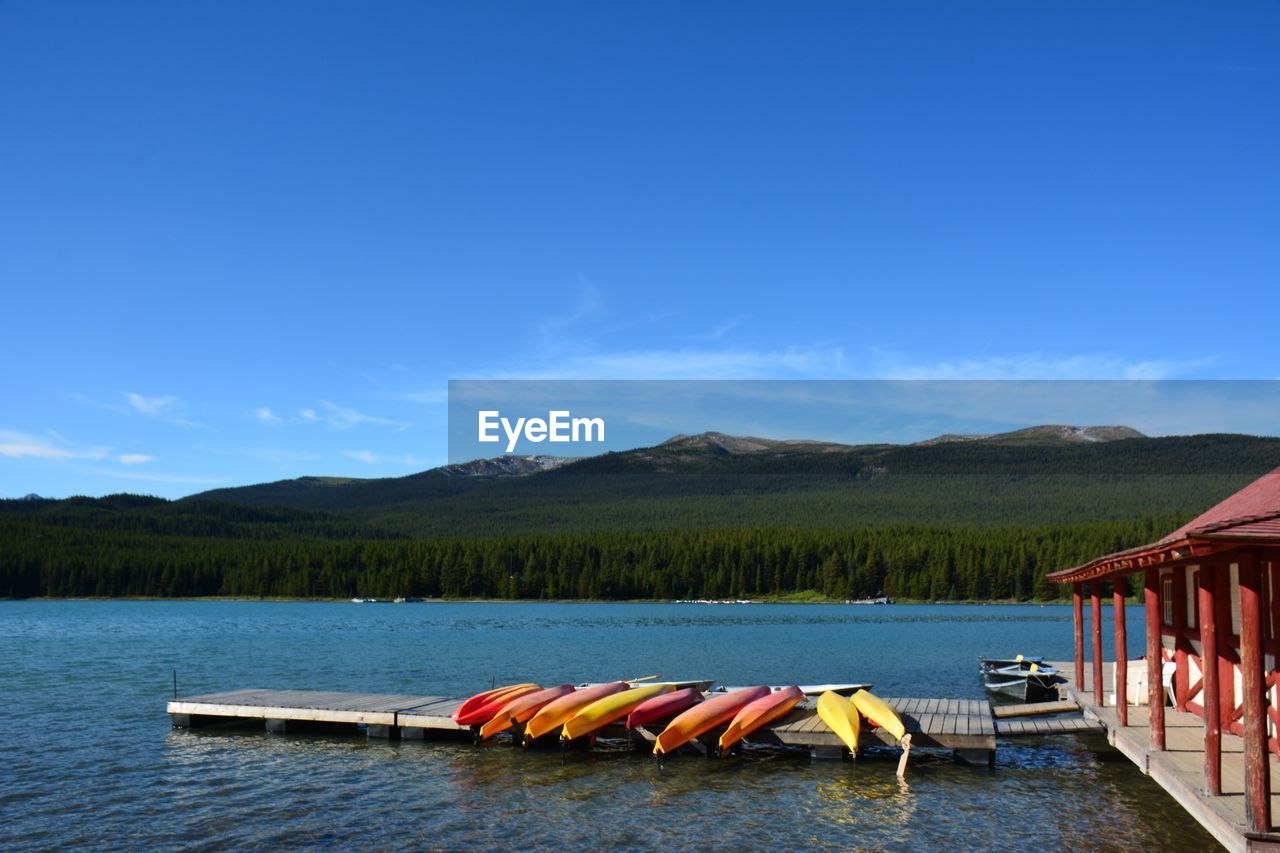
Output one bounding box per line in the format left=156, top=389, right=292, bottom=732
left=0, top=427, right=1280, bottom=599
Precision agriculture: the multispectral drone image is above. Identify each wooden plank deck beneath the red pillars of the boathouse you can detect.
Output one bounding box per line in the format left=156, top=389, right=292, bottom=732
left=1052, top=662, right=1280, bottom=850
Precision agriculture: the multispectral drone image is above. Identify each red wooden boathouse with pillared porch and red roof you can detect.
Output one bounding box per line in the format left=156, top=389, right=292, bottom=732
left=1048, top=469, right=1280, bottom=843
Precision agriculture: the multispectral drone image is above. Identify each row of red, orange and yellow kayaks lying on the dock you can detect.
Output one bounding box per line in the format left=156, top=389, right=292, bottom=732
left=453, top=681, right=906, bottom=756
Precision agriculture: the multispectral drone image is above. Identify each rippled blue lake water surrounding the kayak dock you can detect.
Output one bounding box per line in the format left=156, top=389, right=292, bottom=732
left=0, top=602, right=1215, bottom=849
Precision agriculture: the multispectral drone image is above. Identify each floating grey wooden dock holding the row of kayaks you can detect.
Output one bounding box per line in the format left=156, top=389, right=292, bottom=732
left=168, top=689, right=1098, bottom=765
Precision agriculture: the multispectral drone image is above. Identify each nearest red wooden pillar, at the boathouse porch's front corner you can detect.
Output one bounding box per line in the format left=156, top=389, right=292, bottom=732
left=1238, top=553, right=1271, bottom=833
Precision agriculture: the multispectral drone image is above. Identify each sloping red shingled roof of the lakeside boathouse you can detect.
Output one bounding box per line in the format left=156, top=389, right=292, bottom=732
left=1048, top=467, right=1280, bottom=584
